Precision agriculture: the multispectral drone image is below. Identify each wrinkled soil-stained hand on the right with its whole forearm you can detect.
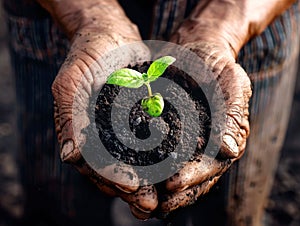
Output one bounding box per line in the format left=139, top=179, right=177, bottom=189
left=159, top=0, right=295, bottom=215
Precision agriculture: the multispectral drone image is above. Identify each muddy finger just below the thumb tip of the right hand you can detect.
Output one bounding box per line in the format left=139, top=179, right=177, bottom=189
left=166, top=155, right=232, bottom=192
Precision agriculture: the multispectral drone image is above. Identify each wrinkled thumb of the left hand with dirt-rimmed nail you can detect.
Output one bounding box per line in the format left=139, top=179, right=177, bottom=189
left=52, top=38, right=150, bottom=163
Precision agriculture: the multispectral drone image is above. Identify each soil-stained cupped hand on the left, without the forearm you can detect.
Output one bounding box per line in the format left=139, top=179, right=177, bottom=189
left=48, top=3, right=158, bottom=219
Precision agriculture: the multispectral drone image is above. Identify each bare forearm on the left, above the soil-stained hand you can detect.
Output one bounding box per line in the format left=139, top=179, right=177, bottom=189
left=36, top=0, right=140, bottom=39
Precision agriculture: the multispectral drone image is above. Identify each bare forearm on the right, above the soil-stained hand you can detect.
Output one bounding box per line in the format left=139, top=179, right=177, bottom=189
left=171, top=0, right=295, bottom=57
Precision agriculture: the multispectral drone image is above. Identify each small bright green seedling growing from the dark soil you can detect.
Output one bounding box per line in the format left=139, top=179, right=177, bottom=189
left=107, top=56, right=176, bottom=117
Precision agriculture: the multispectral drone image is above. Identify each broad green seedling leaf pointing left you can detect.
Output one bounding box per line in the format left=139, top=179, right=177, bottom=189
left=106, top=68, right=144, bottom=88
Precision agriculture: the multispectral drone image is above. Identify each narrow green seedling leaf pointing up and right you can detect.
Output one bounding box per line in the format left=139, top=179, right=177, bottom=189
left=147, top=56, right=176, bottom=82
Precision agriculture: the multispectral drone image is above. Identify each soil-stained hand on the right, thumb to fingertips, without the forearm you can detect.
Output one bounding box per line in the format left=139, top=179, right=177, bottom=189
left=158, top=42, right=251, bottom=217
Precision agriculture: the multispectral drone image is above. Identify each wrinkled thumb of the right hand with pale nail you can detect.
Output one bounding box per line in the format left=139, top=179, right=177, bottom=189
left=179, top=42, right=252, bottom=158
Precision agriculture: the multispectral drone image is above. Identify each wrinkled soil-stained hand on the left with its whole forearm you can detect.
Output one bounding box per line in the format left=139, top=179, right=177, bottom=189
left=36, top=0, right=157, bottom=219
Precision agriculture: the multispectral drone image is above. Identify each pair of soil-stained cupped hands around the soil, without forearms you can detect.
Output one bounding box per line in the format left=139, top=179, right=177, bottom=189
left=52, top=9, right=251, bottom=219
